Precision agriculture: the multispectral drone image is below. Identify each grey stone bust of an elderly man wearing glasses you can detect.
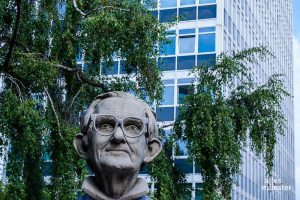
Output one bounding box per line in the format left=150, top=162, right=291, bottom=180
left=73, top=92, right=161, bottom=200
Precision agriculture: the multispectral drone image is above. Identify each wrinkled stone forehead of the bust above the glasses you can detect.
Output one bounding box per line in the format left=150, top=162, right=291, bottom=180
left=95, top=97, right=146, bottom=118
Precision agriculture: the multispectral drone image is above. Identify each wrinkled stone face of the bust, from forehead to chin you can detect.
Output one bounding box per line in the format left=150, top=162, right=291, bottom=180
left=88, top=97, right=148, bottom=171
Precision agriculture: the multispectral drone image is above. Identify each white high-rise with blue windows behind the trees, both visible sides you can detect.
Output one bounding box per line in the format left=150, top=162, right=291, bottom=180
left=144, top=0, right=295, bottom=200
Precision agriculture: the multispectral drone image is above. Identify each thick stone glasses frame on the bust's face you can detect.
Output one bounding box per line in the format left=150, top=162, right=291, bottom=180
left=88, top=114, right=149, bottom=138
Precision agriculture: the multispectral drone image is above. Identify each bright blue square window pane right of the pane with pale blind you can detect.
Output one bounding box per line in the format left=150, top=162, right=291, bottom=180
left=198, top=33, right=216, bottom=53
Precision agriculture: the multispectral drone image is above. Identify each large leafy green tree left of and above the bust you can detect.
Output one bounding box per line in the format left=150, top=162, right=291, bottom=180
left=0, top=0, right=172, bottom=200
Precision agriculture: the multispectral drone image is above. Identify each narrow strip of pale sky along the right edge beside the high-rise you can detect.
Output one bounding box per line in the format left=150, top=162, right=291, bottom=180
left=293, top=0, right=300, bottom=200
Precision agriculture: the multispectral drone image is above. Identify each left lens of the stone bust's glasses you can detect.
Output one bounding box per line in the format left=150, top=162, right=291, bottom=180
left=95, top=115, right=117, bottom=135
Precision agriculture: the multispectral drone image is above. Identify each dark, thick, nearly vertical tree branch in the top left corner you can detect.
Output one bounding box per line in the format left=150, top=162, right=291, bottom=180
left=3, top=0, right=21, bottom=71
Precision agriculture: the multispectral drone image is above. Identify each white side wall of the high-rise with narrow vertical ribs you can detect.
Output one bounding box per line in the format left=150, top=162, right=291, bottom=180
left=223, top=0, right=295, bottom=199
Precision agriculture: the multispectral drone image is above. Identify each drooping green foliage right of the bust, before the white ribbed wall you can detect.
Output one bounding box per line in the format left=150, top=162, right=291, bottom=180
left=175, top=48, right=288, bottom=199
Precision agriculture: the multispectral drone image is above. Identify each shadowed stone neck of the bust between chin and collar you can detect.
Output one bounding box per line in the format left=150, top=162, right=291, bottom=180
left=96, top=171, right=139, bottom=198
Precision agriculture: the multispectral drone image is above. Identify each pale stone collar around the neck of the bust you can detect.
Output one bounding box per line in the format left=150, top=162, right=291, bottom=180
left=82, top=176, right=149, bottom=200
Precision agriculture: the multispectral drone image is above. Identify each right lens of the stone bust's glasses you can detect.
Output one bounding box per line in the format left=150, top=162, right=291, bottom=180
left=123, top=117, right=144, bottom=137
